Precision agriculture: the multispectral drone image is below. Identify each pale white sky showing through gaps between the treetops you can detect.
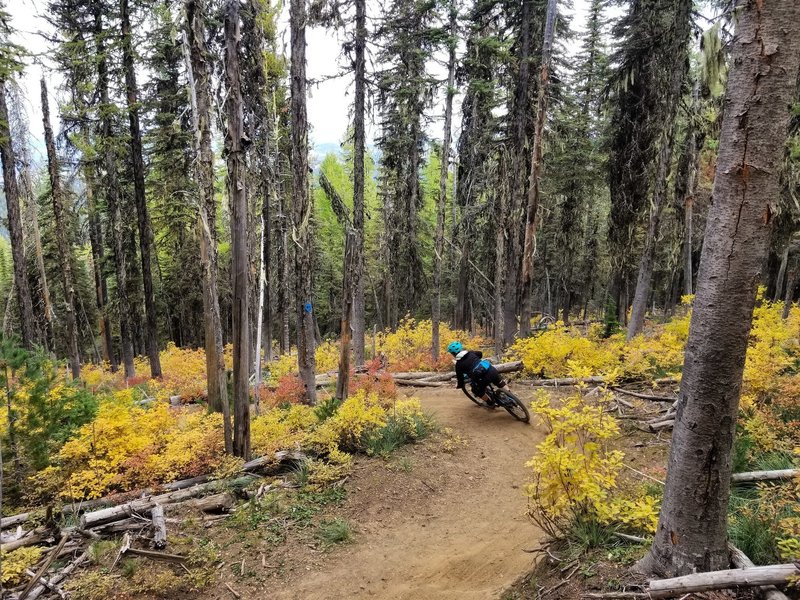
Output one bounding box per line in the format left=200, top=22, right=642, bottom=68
left=7, top=0, right=600, bottom=165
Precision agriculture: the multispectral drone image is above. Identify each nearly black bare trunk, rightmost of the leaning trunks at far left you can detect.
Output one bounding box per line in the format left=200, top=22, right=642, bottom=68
left=120, top=0, right=161, bottom=378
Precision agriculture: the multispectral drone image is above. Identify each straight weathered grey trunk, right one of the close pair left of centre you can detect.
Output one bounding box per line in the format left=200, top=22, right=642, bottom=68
left=225, top=0, right=250, bottom=460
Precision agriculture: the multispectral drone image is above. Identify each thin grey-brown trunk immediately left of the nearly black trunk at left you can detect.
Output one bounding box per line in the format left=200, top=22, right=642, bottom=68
left=94, top=3, right=136, bottom=378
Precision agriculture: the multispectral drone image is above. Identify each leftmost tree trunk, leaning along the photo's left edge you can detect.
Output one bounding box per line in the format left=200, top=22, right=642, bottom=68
left=0, top=78, right=37, bottom=349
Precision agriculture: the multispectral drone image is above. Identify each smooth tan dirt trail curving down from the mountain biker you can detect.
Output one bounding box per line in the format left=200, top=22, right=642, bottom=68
left=266, top=388, right=542, bottom=600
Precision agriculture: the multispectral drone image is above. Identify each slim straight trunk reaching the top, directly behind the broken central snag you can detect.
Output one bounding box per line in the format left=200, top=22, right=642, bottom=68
left=352, top=0, right=367, bottom=365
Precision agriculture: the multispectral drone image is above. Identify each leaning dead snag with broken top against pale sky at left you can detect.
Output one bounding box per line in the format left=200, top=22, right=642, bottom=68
left=41, top=77, right=81, bottom=379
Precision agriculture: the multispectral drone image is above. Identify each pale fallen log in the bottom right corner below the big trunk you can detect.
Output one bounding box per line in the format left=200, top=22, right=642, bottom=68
left=647, top=564, right=800, bottom=598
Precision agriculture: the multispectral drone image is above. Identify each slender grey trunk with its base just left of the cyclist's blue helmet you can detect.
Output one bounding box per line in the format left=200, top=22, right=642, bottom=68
left=431, top=1, right=458, bottom=362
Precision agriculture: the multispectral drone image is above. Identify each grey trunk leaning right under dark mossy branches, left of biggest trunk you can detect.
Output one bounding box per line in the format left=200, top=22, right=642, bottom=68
left=627, top=124, right=678, bottom=340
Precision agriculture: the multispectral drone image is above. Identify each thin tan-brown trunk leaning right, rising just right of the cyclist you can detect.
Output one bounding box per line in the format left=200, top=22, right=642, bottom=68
left=520, top=0, right=558, bottom=335
